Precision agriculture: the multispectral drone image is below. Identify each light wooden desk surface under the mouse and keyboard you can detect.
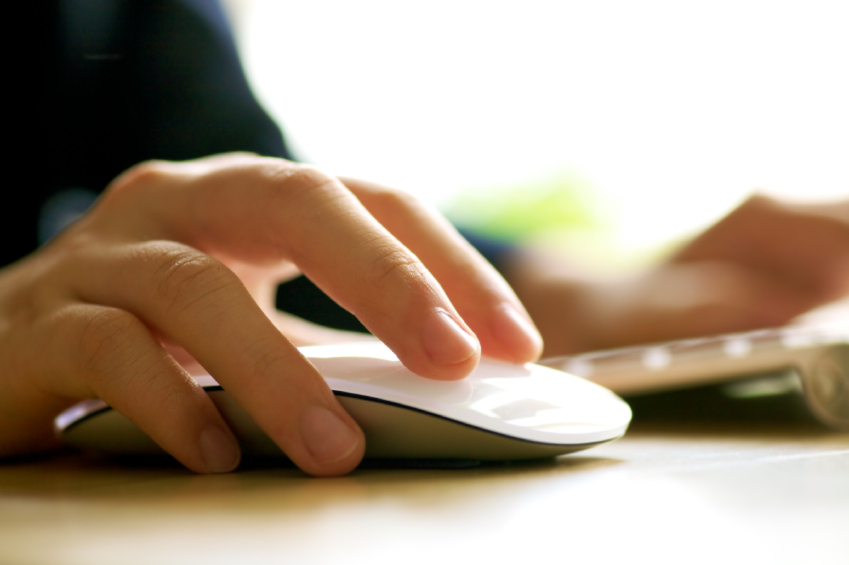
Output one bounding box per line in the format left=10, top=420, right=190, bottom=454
left=0, top=423, right=849, bottom=565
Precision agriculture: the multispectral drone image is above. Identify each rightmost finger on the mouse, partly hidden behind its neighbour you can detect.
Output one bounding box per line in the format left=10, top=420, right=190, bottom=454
left=342, top=178, right=542, bottom=363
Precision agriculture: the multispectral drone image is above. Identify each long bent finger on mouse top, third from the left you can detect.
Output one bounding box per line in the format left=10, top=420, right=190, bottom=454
left=95, top=158, right=480, bottom=379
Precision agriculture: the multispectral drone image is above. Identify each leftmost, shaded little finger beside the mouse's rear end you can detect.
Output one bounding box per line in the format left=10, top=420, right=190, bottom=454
left=37, top=305, right=240, bottom=473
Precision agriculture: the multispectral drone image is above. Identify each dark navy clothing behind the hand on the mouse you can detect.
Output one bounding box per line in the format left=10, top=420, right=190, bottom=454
left=13, top=0, right=510, bottom=329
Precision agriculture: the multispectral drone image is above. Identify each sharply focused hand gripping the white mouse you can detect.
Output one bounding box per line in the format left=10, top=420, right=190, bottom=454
left=0, top=154, right=541, bottom=475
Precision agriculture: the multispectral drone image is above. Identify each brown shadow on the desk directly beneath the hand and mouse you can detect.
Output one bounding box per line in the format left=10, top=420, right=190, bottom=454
left=0, top=446, right=622, bottom=502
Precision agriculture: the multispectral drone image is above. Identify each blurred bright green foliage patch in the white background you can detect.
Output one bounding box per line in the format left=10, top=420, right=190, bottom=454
left=443, top=171, right=611, bottom=242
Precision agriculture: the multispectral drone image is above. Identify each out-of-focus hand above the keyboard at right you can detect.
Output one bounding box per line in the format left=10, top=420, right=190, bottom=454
left=507, top=196, right=849, bottom=355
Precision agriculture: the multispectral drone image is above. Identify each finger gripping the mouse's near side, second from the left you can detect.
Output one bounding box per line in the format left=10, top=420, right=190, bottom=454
left=62, top=242, right=364, bottom=475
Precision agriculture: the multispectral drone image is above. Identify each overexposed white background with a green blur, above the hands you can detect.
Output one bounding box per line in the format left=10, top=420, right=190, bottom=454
left=225, top=0, right=849, bottom=271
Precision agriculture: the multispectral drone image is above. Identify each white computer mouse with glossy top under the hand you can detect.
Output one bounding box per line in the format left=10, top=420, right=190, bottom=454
left=55, top=341, right=631, bottom=460
